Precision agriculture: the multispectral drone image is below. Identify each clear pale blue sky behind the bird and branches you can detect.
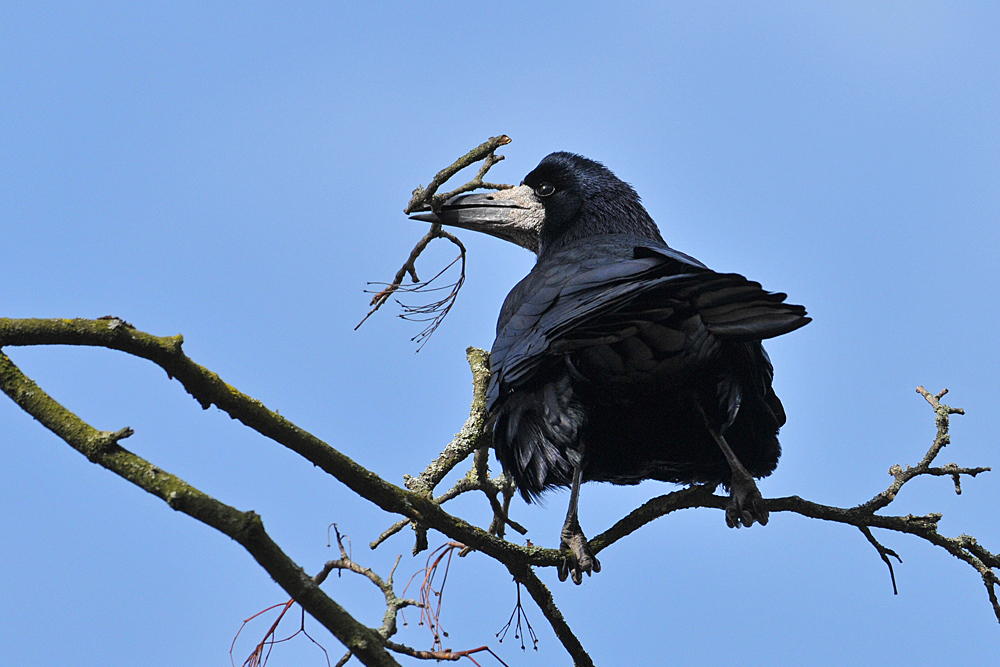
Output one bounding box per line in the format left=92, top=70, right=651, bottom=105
left=0, top=2, right=1000, bottom=666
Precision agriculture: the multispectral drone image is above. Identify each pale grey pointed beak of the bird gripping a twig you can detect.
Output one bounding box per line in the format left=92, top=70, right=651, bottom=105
left=410, top=185, right=545, bottom=253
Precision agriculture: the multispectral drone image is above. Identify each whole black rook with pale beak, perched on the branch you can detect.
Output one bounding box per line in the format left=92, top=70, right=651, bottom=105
left=414, top=153, right=810, bottom=583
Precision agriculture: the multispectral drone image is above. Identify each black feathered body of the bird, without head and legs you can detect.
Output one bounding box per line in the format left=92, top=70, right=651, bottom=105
left=487, top=234, right=804, bottom=497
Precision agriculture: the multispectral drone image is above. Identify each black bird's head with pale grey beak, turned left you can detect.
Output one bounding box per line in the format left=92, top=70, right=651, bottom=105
left=411, top=153, right=662, bottom=255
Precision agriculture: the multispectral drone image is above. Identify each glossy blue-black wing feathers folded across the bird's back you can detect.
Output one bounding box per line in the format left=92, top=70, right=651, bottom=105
left=490, top=245, right=809, bottom=404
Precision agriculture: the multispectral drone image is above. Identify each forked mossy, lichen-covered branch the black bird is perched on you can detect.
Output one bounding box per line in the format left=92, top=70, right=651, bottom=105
left=0, top=318, right=1000, bottom=665
